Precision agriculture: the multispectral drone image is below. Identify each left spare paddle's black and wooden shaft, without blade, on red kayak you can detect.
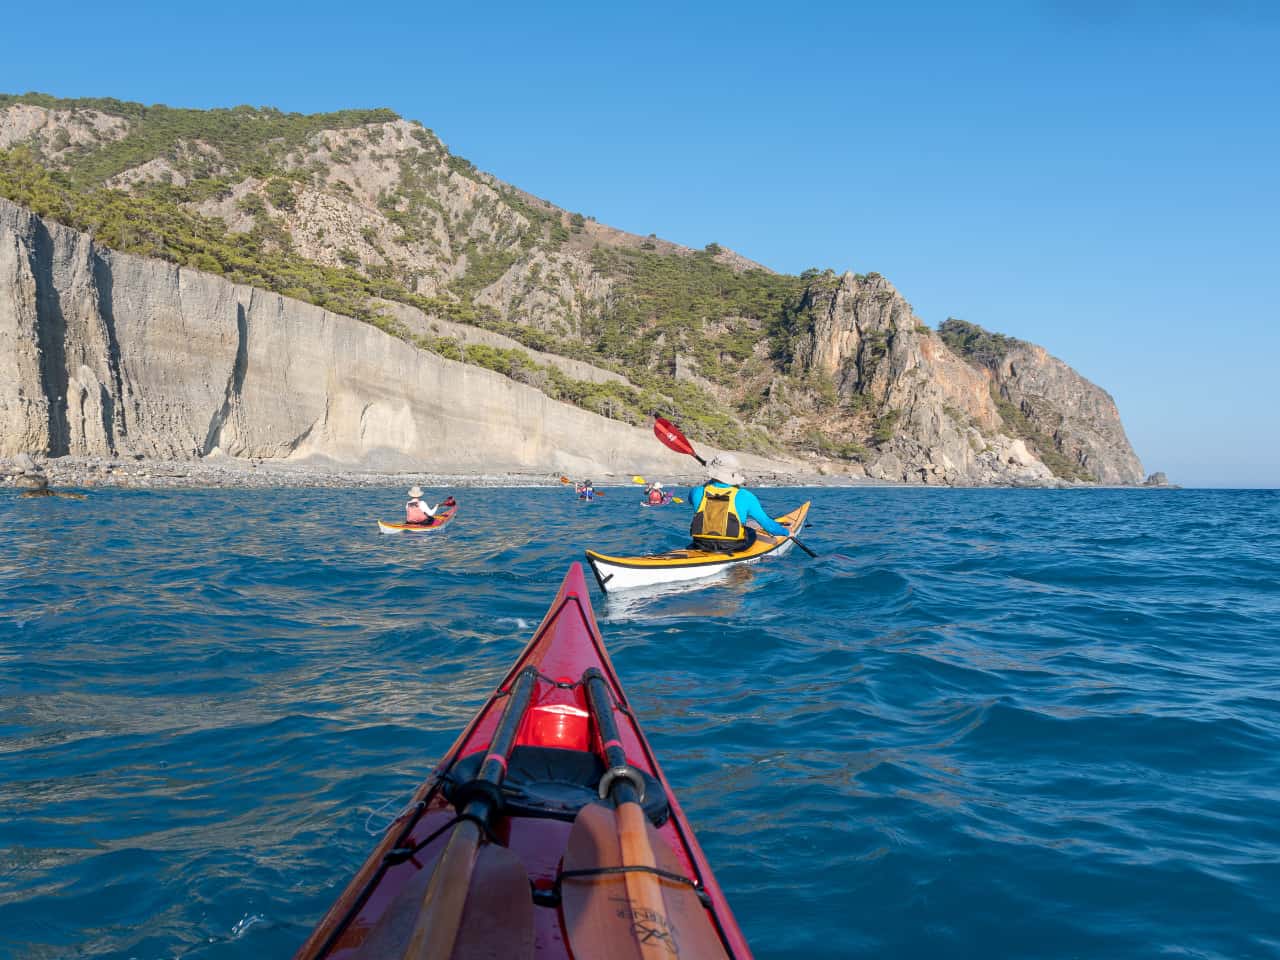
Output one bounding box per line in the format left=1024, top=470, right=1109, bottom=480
left=404, top=667, right=538, bottom=960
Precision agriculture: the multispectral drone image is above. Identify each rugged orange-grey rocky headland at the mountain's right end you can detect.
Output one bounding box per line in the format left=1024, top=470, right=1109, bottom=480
left=795, top=274, right=1143, bottom=484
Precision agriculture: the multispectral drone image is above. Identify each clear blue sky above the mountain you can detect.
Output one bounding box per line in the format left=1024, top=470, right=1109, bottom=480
left=0, top=0, right=1280, bottom=486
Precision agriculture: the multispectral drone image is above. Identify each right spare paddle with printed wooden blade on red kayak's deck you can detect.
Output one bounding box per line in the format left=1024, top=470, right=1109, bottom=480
left=559, top=667, right=728, bottom=960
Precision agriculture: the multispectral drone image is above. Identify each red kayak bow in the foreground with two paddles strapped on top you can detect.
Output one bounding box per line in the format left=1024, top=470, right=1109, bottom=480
left=296, top=563, right=751, bottom=960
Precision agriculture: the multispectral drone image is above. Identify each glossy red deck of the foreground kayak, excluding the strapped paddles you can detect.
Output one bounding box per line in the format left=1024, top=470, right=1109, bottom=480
left=297, top=563, right=750, bottom=960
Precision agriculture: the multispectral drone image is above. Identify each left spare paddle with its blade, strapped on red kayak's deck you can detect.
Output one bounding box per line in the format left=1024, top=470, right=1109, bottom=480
left=378, top=667, right=538, bottom=960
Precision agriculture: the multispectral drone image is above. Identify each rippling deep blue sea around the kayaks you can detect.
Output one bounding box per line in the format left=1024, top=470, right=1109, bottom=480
left=0, top=488, right=1280, bottom=960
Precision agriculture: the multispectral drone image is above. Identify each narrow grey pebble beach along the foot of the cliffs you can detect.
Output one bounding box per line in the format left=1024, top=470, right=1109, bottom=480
left=0, top=456, right=1179, bottom=490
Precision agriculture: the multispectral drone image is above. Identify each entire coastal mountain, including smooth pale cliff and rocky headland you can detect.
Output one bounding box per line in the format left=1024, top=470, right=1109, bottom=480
left=0, top=95, right=1143, bottom=485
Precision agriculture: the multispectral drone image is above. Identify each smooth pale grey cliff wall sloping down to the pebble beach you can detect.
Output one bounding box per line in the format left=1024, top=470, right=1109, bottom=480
left=0, top=200, right=721, bottom=472
